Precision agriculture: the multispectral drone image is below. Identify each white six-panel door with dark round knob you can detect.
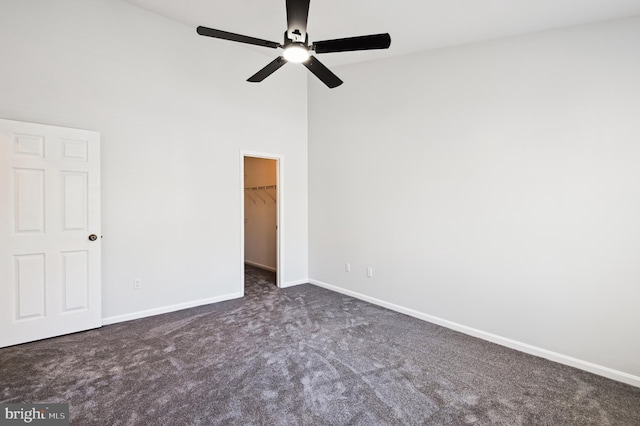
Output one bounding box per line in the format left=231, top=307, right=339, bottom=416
left=0, top=119, right=102, bottom=347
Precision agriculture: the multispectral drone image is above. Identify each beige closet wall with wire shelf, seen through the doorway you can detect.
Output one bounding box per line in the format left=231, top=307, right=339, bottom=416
left=244, top=157, right=278, bottom=271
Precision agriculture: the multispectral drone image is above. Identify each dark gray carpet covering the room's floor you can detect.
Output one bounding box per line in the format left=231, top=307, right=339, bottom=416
left=0, top=266, right=640, bottom=426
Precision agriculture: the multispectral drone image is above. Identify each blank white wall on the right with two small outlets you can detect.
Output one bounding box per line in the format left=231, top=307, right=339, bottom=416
left=308, top=18, right=640, bottom=385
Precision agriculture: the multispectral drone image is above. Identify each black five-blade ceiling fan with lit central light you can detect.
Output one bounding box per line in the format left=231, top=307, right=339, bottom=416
left=197, top=0, right=391, bottom=89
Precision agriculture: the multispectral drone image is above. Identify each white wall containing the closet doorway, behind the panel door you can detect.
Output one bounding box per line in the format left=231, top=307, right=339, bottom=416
left=0, top=0, right=307, bottom=320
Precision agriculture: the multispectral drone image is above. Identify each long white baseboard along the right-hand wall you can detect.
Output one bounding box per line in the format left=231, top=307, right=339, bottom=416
left=309, top=279, right=640, bottom=387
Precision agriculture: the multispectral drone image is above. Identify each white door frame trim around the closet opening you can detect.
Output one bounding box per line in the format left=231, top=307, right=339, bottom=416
left=240, top=149, right=284, bottom=296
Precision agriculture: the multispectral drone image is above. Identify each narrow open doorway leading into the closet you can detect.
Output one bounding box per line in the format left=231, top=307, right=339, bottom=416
left=241, top=152, right=280, bottom=293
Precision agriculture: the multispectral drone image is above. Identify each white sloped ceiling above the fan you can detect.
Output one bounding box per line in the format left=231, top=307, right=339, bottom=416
left=120, top=0, right=640, bottom=66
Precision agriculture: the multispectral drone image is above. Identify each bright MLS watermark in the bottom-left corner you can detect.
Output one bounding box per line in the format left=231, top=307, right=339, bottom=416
left=0, top=404, right=69, bottom=426
